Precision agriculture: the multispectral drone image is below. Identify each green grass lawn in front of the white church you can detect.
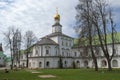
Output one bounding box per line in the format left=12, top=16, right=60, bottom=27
left=0, top=69, right=120, bottom=80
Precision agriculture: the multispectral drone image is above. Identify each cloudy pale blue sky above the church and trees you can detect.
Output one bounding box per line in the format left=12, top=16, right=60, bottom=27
left=0, top=0, right=120, bottom=54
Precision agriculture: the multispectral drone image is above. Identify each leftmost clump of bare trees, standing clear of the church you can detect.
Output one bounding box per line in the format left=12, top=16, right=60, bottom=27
left=3, top=27, right=21, bottom=69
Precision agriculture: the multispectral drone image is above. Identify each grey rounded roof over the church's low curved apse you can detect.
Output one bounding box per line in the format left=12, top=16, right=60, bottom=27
left=36, top=37, right=58, bottom=45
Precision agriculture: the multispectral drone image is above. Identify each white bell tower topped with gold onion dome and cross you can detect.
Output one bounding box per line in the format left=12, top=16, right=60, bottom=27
left=52, top=9, right=62, bottom=33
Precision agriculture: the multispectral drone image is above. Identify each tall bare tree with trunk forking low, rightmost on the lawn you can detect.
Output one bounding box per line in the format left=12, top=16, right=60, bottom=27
left=92, top=0, right=116, bottom=71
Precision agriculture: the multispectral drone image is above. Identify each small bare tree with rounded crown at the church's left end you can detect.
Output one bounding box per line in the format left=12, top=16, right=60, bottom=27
left=24, top=31, right=37, bottom=67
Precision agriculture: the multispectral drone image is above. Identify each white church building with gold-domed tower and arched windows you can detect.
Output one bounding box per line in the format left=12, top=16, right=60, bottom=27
left=20, top=12, right=120, bottom=68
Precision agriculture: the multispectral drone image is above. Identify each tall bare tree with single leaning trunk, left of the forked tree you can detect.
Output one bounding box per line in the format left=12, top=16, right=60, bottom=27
left=76, top=0, right=98, bottom=71
